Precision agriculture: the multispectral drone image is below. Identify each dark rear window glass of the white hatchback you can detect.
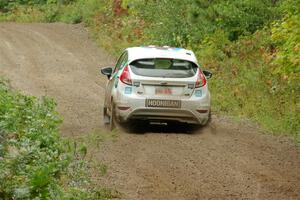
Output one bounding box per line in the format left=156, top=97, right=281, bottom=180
left=130, top=58, right=197, bottom=78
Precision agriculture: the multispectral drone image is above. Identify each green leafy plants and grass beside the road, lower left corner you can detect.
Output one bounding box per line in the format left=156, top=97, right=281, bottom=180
left=0, top=79, right=121, bottom=200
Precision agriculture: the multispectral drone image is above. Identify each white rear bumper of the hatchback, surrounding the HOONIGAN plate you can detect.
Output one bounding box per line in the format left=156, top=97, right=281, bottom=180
left=115, top=92, right=210, bottom=125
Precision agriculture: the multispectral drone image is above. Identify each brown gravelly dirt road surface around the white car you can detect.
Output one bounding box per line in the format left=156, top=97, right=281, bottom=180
left=0, top=23, right=300, bottom=200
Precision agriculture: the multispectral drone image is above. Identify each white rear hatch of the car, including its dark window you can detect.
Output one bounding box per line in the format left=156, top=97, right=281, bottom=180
left=129, top=58, right=198, bottom=99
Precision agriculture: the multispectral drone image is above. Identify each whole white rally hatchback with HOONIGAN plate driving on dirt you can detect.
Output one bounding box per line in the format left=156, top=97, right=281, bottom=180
left=101, top=46, right=212, bottom=129
